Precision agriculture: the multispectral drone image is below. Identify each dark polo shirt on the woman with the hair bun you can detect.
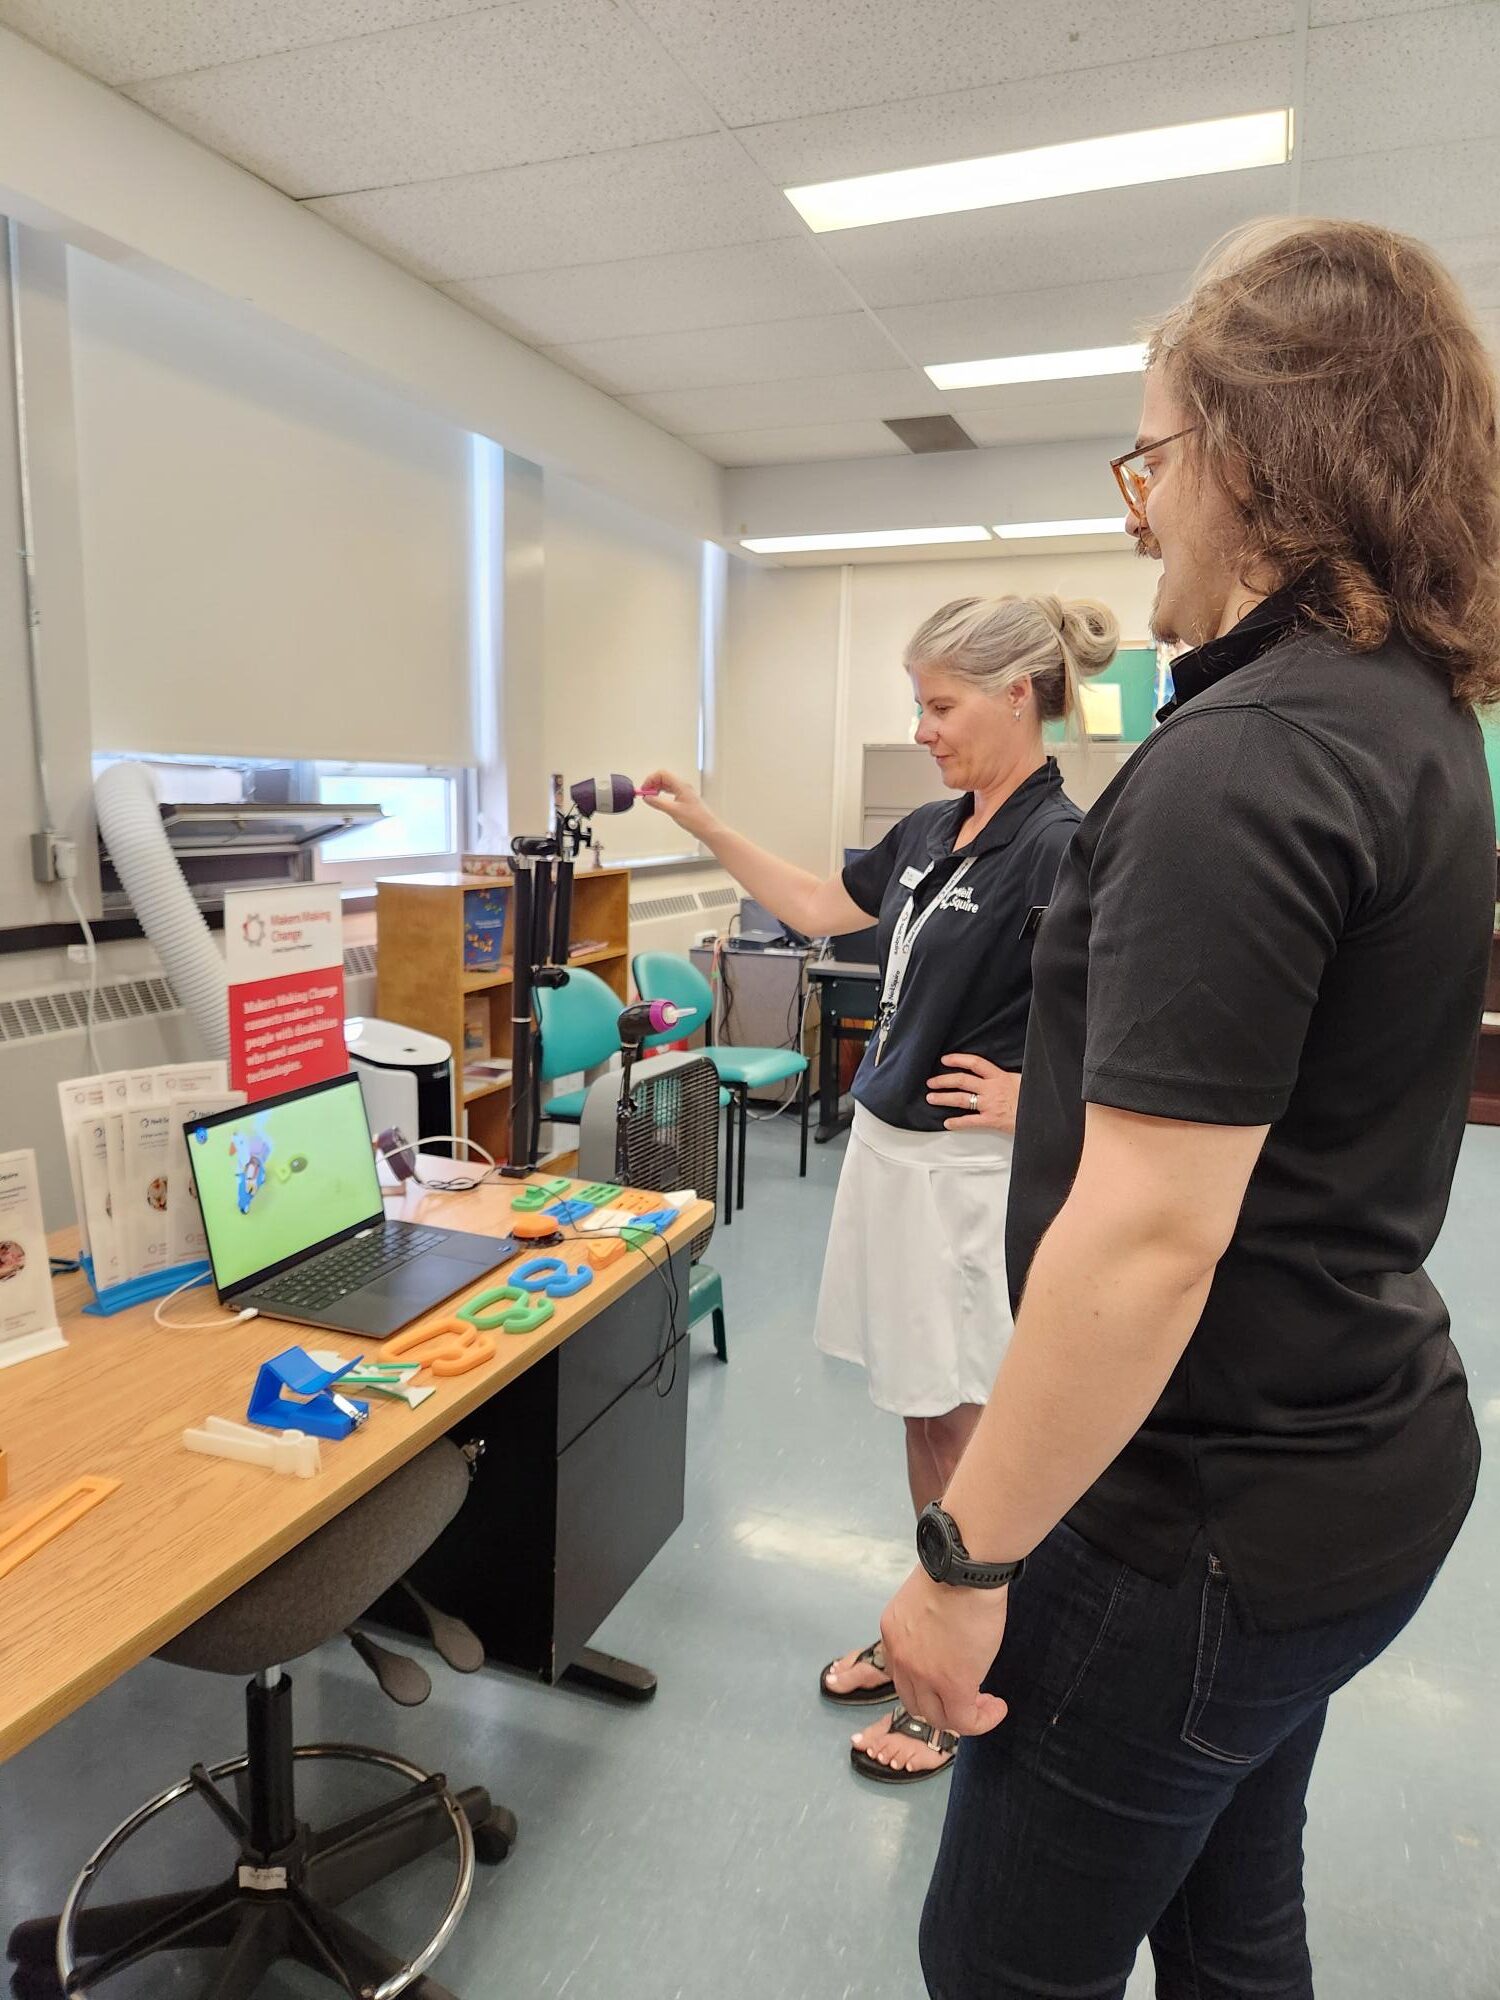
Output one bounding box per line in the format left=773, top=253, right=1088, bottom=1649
left=844, top=758, right=1080, bottom=1132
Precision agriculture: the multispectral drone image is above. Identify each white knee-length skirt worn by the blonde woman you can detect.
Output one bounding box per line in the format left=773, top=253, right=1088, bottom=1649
left=814, top=1104, right=1014, bottom=1416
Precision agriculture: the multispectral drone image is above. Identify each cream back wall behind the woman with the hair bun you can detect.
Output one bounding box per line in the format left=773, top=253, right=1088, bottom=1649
left=718, top=552, right=1156, bottom=872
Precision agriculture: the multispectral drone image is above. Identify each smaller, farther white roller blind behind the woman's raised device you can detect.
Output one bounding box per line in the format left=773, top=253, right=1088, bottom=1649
left=544, top=474, right=702, bottom=862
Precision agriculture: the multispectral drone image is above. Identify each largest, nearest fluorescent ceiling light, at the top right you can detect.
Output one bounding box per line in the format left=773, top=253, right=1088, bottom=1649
left=786, top=110, right=1292, bottom=234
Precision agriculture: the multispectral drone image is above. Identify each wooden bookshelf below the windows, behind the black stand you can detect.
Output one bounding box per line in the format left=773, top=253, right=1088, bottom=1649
left=376, top=868, right=630, bottom=1160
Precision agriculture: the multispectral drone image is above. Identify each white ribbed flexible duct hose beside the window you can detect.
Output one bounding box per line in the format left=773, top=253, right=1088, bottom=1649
left=94, top=764, right=230, bottom=1060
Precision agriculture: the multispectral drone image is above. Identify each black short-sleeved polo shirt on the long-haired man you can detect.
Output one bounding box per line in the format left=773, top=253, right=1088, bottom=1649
left=1006, top=592, right=1496, bottom=1628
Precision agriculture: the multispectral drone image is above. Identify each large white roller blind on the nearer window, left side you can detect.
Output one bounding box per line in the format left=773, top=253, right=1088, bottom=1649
left=70, top=252, right=474, bottom=764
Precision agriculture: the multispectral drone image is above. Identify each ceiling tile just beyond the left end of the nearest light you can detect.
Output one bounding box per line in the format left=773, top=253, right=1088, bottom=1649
left=448, top=236, right=850, bottom=346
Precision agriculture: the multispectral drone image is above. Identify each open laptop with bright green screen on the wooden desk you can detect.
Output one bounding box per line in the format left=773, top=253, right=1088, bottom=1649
left=184, top=1076, right=508, bottom=1340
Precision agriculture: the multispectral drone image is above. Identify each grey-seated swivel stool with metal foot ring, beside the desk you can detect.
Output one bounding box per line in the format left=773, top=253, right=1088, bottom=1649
left=10, top=1438, right=516, bottom=2000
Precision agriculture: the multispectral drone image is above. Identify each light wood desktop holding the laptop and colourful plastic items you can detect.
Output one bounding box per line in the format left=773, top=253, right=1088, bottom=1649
left=0, top=1162, right=710, bottom=1758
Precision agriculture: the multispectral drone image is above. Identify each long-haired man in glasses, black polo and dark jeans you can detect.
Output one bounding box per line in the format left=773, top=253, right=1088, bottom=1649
left=882, top=220, right=1500, bottom=2000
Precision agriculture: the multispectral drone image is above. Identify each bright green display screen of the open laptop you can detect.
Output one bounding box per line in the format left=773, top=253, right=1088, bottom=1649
left=186, top=1076, right=384, bottom=1294
